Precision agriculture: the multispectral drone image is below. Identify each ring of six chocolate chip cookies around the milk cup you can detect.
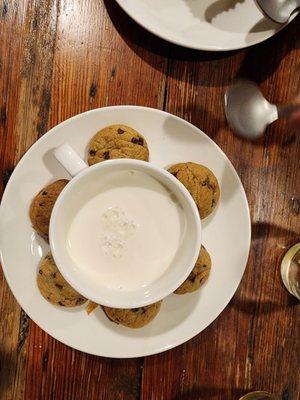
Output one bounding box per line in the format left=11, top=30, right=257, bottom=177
left=29, top=125, right=220, bottom=328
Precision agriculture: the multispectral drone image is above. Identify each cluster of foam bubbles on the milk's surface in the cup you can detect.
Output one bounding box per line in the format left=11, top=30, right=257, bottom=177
left=101, top=206, right=139, bottom=258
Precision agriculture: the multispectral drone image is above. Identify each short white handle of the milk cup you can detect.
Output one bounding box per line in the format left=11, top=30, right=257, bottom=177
left=54, top=143, right=88, bottom=177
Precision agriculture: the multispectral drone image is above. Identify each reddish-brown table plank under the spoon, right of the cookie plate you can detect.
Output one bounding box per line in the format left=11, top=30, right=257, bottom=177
left=142, top=17, right=300, bottom=400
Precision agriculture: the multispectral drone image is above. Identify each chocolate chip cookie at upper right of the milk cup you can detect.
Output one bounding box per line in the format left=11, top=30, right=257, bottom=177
left=168, top=162, right=220, bottom=218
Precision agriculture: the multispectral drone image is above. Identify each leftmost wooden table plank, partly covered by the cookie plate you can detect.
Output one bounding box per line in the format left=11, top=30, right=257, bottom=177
left=1, top=0, right=63, bottom=399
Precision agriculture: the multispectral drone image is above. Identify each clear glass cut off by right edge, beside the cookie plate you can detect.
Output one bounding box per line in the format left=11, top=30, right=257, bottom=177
left=281, top=243, right=300, bottom=300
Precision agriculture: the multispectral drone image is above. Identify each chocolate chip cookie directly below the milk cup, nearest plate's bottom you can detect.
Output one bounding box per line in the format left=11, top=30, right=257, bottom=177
left=103, top=301, right=162, bottom=328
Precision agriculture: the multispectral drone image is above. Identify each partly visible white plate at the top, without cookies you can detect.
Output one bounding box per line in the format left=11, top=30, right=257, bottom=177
left=116, top=0, right=296, bottom=51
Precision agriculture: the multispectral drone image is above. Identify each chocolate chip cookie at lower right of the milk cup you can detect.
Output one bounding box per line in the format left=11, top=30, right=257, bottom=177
left=174, top=246, right=211, bottom=294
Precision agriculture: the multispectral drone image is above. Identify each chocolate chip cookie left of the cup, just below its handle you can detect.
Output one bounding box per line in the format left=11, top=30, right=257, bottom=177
left=29, top=179, right=69, bottom=239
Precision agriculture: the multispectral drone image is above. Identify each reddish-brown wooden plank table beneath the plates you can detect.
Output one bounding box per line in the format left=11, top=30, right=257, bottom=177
left=0, top=0, right=300, bottom=400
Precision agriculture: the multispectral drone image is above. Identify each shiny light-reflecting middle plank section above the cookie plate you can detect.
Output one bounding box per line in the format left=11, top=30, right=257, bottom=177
left=49, top=0, right=167, bottom=126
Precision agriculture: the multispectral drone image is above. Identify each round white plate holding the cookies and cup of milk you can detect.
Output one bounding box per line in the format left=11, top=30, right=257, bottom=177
left=0, top=106, right=251, bottom=358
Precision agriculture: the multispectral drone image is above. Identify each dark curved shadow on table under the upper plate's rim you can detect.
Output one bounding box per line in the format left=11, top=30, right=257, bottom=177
left=104, top=0, right=300, bottom=86
